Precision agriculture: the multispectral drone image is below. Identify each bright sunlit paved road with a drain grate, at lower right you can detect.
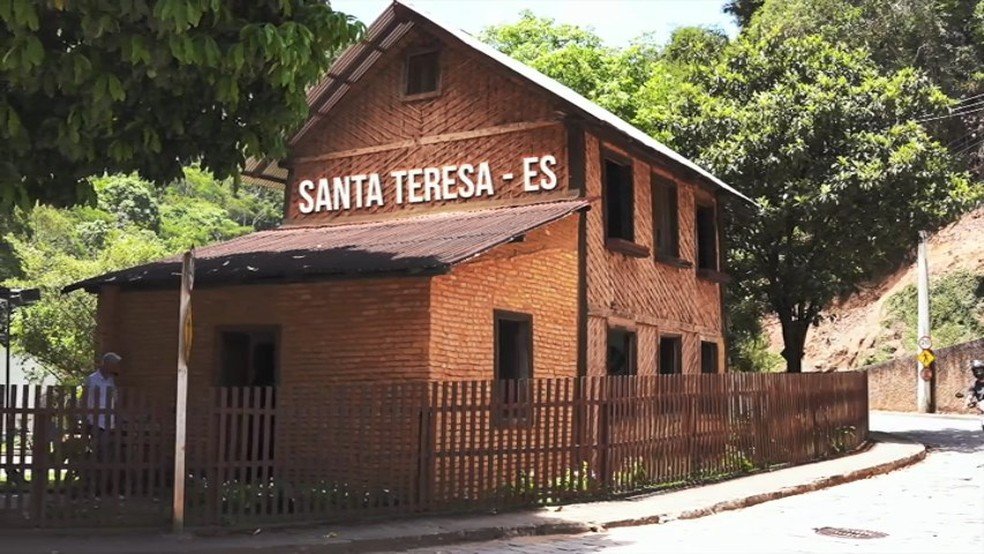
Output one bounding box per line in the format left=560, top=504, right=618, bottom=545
left=400, top=414, right=984, bottom=554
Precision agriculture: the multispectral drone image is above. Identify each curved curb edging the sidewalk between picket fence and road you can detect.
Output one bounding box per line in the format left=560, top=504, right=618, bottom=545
left=324, top=433, right=926, bottom=553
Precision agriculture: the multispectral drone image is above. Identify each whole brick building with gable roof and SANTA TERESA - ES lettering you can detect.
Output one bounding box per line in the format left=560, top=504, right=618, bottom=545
left=69, top=2, right=749, bottom=390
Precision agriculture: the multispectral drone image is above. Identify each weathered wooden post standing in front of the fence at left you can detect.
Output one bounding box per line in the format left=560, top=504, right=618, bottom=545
left=173, top=250, right=195, bottom=533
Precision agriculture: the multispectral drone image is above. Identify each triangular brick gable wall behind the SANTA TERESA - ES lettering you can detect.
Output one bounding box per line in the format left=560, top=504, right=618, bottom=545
left=286, top=30, right=568, bottom=224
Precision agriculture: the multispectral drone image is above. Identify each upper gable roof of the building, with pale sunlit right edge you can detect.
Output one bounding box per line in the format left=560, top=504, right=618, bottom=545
left=243, top=0, right=755, bottom=204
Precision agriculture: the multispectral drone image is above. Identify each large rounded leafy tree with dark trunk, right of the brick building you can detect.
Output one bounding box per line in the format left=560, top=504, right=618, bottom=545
left=643, top=33, right=981, bottom=372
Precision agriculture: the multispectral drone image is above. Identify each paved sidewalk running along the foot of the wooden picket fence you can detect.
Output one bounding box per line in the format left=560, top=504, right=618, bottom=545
left=0, top=433, right=926, bottom=554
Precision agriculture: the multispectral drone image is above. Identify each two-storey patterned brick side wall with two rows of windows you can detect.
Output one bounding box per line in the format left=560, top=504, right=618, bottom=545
left=585, top=134, right=724, bottom=375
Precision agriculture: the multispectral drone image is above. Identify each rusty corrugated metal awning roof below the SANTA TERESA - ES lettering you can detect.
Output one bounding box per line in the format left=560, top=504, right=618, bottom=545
left=69, top=200, right=590, bottom=292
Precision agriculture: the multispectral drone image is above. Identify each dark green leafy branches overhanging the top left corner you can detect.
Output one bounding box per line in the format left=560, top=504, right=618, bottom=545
left=0, top=0, right=363, bottom=211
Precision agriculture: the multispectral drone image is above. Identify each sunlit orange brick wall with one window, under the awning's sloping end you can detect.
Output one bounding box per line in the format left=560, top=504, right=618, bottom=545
left=430, top=215, right=580, bottom=380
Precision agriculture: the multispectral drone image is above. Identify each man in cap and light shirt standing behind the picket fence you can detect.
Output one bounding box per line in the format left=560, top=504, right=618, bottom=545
left=83, top=352, right=123, bottom=494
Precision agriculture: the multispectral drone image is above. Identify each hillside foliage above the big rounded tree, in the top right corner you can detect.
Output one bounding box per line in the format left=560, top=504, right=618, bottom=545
left=745, top=0, right=984, bottom=178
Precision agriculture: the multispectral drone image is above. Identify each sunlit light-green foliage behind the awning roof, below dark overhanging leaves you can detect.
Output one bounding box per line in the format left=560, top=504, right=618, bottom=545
left=0, top=168, right=283, bottom=383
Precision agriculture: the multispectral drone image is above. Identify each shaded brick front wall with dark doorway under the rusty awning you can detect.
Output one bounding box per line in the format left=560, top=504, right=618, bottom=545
left=99, top=277, right=430, bottom=390
